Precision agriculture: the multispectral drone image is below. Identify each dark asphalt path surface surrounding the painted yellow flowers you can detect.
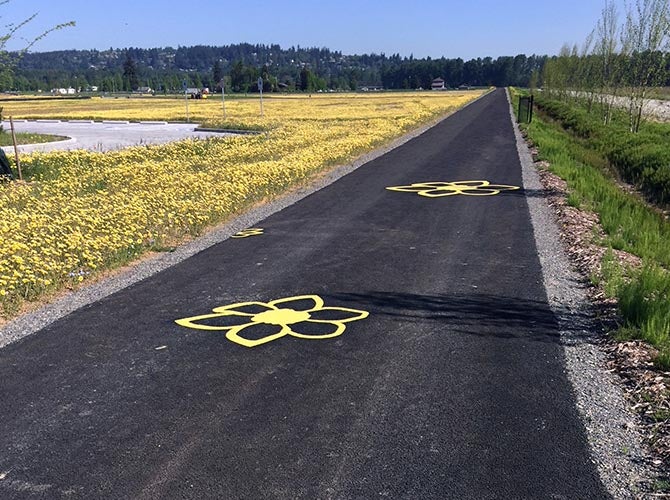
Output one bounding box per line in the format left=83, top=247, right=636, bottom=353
left=0, top=90, right=608, bottom=499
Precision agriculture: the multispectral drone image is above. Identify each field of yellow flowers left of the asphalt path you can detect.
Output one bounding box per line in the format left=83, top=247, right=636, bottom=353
left=0, top=91, right=481, bottom=319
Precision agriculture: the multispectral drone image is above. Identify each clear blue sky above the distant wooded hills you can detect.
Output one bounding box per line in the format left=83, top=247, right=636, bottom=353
left=0, top=0, right=624, bottom=59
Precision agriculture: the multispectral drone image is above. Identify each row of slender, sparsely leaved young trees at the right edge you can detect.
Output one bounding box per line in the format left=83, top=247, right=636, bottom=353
left=544, top=0, right=670, bottom=132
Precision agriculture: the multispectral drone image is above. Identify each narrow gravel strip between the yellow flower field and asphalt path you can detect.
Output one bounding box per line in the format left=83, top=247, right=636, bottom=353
left=0, top=91, right=491, bottom=349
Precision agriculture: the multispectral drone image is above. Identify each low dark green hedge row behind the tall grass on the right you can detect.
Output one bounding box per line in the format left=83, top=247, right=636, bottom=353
left=535, top=97, right=670, bottom=205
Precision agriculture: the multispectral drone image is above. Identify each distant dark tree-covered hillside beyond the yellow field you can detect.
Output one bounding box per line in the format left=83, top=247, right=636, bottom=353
left=0, top=43, right=546, bottom=92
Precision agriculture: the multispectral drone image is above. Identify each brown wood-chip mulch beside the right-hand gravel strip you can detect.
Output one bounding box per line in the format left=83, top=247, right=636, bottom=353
left=531, top=149, right=670, bottom=475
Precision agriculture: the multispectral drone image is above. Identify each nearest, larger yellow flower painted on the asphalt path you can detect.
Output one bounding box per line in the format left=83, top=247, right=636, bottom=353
left=175, top=295, right=369, bottom=347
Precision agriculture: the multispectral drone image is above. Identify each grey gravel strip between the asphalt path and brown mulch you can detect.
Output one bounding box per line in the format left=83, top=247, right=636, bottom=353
left=507, top=91, right=654, bottom=499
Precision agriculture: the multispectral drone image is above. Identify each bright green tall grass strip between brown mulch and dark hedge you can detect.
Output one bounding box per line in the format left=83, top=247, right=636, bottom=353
left=510, top=88, right=670, bottom=369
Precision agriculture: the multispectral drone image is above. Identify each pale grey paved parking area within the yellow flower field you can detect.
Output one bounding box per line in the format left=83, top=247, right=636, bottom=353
left=2, top=120, right=231, bottom=153
